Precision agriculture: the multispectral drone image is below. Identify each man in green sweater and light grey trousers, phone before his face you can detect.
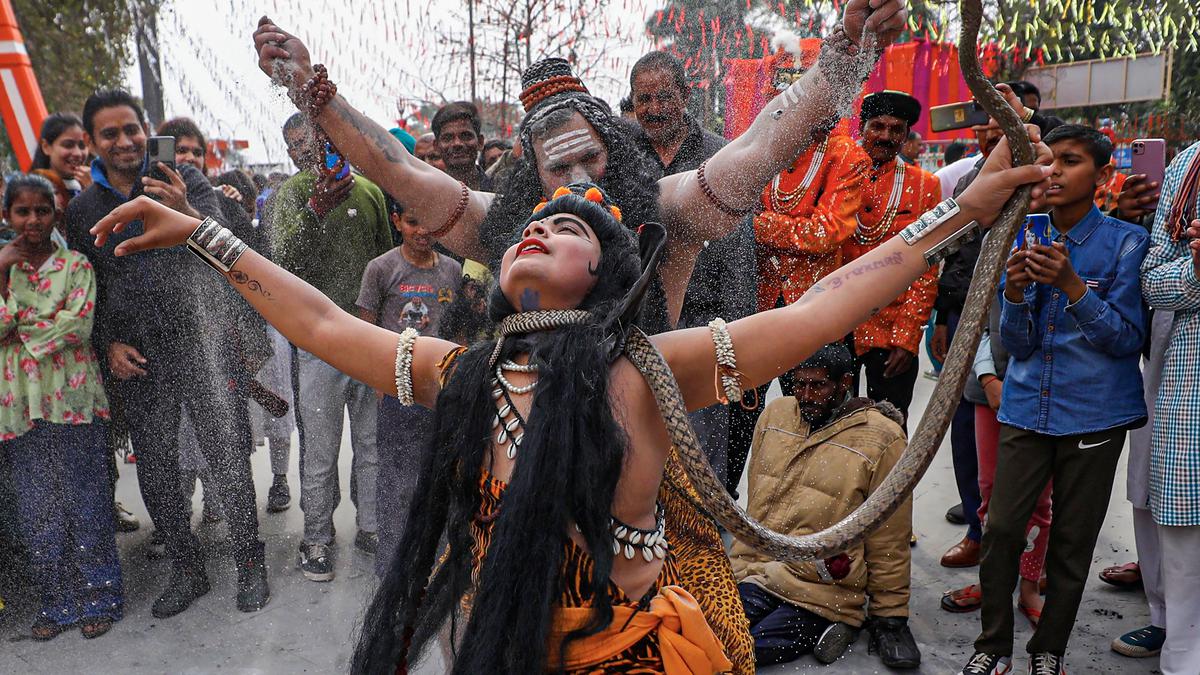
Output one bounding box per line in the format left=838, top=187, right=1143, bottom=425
left=269, top=114, right=392, bottom=581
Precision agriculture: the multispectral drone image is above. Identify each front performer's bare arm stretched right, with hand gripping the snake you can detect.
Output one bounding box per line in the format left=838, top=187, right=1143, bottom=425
left=653, top=127, right=1051, bottom=410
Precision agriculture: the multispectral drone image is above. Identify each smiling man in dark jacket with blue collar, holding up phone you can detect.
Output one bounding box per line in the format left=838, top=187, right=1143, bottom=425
left=66, top=90, right=270, bottom=619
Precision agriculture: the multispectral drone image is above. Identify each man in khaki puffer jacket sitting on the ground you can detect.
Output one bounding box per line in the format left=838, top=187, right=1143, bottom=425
left=730, top=342, right=920, bottom=668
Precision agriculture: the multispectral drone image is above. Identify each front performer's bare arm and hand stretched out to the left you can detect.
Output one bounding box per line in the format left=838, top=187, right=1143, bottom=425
left=91, top=197, right=457, bottom=407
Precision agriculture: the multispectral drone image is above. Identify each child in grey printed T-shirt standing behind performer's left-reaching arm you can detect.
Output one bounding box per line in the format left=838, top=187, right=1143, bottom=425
left=356, top=198, right=462, bottom=575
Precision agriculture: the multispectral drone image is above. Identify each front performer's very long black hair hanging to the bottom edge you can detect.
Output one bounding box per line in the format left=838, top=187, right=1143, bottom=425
left=350, top=185, right=661, bottom=675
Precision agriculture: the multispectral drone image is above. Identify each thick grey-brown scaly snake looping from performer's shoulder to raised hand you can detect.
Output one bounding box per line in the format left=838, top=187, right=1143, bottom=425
left=624, top=0, right=1034, bottom=561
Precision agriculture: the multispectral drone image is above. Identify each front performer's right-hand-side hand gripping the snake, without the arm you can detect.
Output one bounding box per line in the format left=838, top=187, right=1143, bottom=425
left=958, top=125, right=1054, bottom=227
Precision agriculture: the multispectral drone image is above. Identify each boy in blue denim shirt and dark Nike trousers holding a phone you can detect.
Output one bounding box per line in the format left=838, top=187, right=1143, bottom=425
left=961, top=125, right=1150, bottom=675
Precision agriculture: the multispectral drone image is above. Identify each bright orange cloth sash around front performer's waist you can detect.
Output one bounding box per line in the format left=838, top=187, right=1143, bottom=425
left=550, top=586, right=733, bottom=675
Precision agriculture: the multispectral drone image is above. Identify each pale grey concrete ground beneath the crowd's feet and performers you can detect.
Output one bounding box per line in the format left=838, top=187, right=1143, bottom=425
left=0, top=355, right=1158, bottom=675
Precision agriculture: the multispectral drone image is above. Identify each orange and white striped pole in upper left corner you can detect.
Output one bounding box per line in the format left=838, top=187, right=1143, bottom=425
left=0, top=0, right=47, bottom=171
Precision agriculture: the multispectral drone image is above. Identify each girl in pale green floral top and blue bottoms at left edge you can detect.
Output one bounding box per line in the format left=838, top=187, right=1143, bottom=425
left=0, top=175, right=122, bottom=640
